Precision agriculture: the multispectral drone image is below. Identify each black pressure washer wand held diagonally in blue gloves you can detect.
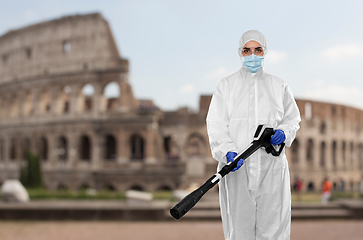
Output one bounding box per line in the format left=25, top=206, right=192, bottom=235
left=170, top=125, right=285, bottom=220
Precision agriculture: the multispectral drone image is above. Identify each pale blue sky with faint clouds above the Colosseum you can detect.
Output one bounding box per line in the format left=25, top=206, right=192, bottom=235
left=0, top=0, right=363, bottom=111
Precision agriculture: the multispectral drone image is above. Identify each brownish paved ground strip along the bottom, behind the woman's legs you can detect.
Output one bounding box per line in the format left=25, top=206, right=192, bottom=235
left=0, top=220, right=363, bottom=240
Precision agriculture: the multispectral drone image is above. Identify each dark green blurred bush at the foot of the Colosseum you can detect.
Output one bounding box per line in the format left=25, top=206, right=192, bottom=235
left=20, top=151, right=43, bottom=189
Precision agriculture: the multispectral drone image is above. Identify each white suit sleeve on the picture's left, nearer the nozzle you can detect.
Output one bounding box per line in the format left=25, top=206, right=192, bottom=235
left=207, top=79, right=238, bottom=164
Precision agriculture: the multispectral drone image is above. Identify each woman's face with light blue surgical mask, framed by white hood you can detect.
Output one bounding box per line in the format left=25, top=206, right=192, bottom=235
left=241, top=41, right=264, bottom=73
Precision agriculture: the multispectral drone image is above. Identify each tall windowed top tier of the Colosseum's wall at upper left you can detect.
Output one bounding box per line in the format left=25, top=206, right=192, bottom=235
left=0, top=14, right=123, bottom=83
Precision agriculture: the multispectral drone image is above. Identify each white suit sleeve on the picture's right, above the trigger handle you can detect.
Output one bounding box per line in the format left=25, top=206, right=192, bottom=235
left=277, top=84, right=301, bottom=147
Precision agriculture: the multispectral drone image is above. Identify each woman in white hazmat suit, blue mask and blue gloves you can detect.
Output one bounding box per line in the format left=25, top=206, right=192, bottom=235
left=206, top=30, right=301, bottom=240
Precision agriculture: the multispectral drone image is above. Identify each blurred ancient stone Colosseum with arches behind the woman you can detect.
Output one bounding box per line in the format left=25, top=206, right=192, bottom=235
left=0, top=13, right=363, bottom=191
